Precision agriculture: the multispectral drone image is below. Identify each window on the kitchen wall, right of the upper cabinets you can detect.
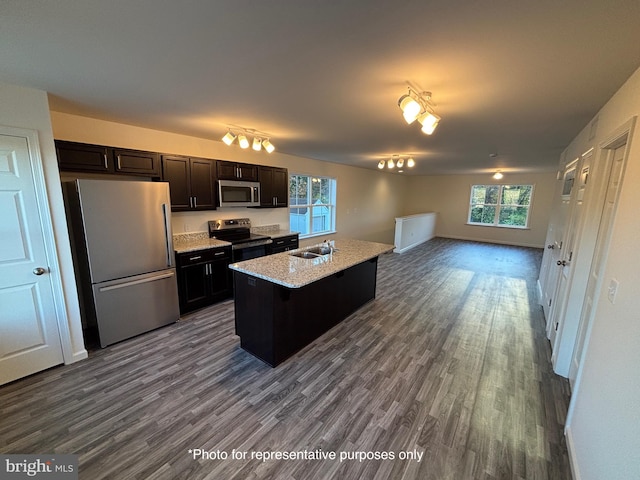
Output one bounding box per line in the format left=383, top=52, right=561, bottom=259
left=289, top=174, right=336, bottom=237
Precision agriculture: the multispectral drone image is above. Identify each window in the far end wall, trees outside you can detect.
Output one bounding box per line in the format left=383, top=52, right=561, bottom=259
left=469, top=185, right=533, bottom=228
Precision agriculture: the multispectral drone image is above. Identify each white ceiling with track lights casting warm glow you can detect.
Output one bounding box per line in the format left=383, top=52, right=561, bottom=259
left=0, top=0, right=640, bottom=174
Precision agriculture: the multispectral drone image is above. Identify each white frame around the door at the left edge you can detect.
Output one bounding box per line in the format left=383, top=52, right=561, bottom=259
left=0, top=125, right=78, bottom=364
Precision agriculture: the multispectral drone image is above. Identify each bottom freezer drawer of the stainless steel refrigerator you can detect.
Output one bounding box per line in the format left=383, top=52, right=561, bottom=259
left=93, top=268, right=180, bottom=347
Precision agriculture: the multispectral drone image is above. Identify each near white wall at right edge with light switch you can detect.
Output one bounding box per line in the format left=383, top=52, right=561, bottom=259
left=567, top=70, right=640, bottom=480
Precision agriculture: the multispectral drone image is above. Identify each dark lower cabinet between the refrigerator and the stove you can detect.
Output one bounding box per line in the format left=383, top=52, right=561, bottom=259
left=176, top=247, right=233, bottom=314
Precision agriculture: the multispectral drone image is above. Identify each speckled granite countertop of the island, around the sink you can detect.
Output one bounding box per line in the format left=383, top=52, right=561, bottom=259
left=229, top=239, right=394, bottom=288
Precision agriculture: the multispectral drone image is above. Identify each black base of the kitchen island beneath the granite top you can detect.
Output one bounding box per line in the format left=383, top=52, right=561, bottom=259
left=233, top=257, right=378, bottom=367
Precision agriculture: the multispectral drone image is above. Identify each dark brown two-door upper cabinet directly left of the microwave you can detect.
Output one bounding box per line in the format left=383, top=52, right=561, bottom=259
left=162, top=155, right=216, bottom=212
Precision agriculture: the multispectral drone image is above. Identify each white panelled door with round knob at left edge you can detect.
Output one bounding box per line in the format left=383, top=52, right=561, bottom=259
left=0, top=134, right=63, bottom=384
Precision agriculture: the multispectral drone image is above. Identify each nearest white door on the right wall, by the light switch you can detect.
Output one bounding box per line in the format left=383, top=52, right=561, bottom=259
left=569, top=144, right=626, bottom=387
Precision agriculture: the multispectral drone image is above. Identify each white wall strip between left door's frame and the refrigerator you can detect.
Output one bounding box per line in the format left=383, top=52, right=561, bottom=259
left=0, top=83, right=87, bottom=363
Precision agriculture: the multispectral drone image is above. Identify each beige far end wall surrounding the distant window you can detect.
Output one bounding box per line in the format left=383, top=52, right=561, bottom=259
left=404, top=172, right=556, bottom=247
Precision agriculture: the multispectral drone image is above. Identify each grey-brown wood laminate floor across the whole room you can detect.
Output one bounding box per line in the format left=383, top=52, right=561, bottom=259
left=0, top=238, right=571, bottom=480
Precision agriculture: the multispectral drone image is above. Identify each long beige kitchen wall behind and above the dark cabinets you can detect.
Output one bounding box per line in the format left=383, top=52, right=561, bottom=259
left=51, top=112, right=407, bottom=248
